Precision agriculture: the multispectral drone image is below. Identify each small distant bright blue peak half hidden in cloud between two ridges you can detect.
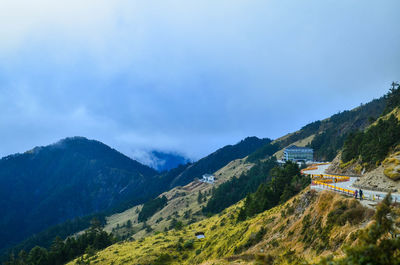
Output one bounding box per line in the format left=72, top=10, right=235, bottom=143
left=149, top=151, right=190, bottom=172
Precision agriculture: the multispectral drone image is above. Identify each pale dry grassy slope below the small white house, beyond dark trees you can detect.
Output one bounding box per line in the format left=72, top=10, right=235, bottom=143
left=105, top=158, right=253, bottom=239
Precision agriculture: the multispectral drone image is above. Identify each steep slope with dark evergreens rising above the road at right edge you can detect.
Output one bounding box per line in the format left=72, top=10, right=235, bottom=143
left=328, top=86, right=400, bottom=192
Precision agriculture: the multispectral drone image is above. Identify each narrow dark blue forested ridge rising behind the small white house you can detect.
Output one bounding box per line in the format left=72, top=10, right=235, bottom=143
left=170, top=136, right=272, bottom=187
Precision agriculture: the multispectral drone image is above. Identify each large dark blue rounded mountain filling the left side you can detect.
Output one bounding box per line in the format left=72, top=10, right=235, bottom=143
left=0, top=137, right=162, bottom=249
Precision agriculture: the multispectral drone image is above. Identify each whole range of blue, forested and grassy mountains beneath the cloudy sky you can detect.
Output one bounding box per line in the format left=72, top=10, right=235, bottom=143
left=0, top=84, right=400, bottom=265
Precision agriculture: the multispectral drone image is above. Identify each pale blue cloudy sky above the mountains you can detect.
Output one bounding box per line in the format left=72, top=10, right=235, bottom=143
left=0, top=0, right=400, bottom=162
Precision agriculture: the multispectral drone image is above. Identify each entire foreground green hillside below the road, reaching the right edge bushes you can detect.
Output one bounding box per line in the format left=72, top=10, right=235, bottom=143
left=63, top=190, right=399, bottom=265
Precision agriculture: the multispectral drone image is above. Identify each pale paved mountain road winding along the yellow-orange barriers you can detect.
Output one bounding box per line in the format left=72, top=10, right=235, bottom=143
left=304, top=164, right=400, bottom=202
